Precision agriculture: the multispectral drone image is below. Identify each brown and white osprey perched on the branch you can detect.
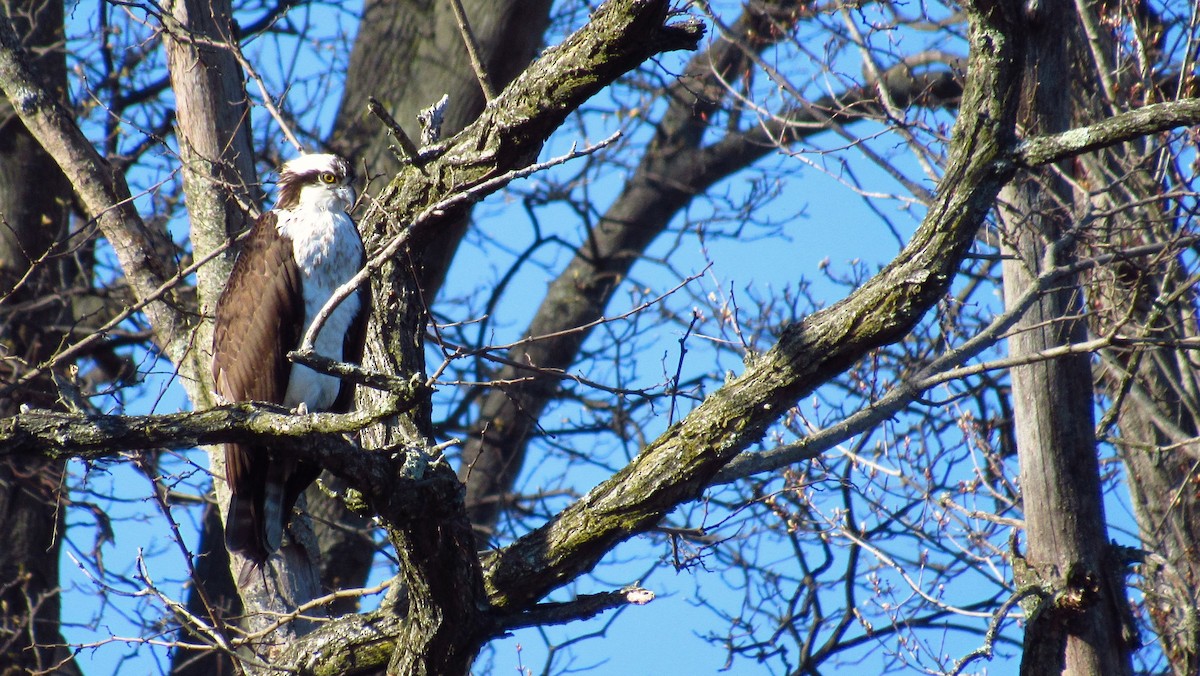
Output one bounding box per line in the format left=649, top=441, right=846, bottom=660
left=212, top=154, right=366, bottom=566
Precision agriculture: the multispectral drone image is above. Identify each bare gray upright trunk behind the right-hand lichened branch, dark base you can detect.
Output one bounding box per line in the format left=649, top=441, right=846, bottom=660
left=1002, top=1, right=1134, bottom=676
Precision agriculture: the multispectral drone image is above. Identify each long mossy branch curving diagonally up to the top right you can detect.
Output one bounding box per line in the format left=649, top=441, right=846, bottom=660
left=485, top=2, right=1020, bottom=609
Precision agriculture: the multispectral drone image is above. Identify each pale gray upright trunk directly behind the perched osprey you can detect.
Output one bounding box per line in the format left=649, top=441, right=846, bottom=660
left=163, top=0, right=320, bottom=670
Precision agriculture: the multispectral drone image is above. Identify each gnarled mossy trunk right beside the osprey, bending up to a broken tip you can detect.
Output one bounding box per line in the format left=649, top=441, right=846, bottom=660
left=264, top=0, right=703, bottom=674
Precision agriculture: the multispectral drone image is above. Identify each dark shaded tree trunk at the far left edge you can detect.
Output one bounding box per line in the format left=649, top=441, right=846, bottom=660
left=0, top=0, right=80, bottom=675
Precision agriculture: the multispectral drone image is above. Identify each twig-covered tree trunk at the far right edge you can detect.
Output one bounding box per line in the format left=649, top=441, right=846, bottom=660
left=1075, top=4, right=1200, bottom=676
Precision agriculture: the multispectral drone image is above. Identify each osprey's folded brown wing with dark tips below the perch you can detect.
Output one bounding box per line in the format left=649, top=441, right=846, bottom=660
left=212, top=211, right=304, bottom=563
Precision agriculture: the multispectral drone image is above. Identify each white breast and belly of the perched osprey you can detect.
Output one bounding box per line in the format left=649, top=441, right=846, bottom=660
left=276, top=203, right=362, bottom=411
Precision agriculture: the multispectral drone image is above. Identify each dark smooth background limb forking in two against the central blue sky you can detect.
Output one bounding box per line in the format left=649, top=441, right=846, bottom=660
left=460, top=1, right=962, bottom=548
